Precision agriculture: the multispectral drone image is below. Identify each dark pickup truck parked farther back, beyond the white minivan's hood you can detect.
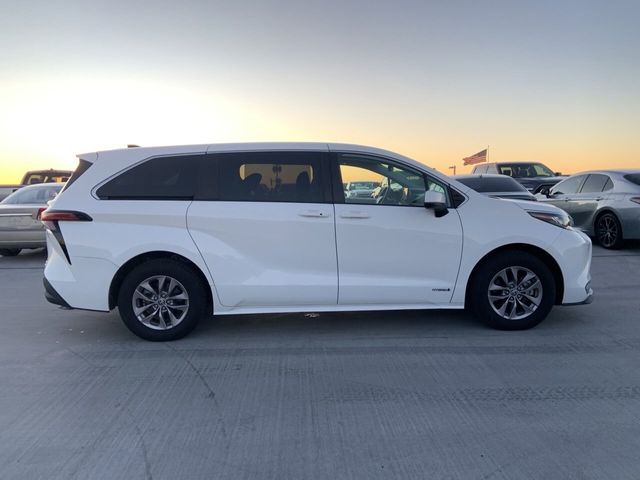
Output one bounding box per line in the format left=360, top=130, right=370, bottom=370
left=471, top=162, right=565, bottom=194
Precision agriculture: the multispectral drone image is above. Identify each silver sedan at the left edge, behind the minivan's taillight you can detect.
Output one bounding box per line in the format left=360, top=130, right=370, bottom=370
left=0, top=183, right=64, bottom=257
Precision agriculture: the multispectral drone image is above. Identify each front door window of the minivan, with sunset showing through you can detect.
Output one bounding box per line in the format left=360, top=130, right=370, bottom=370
left=339, top=153, right=438, bottom=207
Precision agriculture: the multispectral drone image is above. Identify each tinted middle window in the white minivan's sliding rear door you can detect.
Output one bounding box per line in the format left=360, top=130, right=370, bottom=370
left=216, top=152, right=329, bottom=203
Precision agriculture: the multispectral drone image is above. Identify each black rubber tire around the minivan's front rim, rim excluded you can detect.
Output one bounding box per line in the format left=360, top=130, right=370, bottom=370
left=470, top=251, right=556, bottom=330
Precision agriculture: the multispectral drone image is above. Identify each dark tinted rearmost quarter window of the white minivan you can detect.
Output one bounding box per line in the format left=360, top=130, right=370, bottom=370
left=96, top=155, right=206, bottom=200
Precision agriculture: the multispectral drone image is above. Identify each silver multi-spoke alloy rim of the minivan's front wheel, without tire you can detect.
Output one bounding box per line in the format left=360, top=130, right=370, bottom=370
left=487, top=266, right=542, bottom=320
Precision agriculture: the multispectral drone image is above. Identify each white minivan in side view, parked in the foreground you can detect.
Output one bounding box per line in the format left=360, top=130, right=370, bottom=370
left=41, top=143, right=592, bottom=341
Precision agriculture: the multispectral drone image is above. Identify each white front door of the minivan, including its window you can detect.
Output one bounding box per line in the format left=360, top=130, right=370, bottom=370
left=335, top=153, right=462, bottom=306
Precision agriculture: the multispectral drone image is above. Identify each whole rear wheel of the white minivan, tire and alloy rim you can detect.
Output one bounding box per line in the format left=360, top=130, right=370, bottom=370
left=118, top=258, right=207, bottom=341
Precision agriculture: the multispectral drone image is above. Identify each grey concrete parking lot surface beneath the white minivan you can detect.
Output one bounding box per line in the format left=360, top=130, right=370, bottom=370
left=0, top=244, right=640, bottom=480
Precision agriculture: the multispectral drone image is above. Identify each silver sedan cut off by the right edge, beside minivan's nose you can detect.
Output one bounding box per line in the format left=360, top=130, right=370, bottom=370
left=540, top=170, right=640, bottom=248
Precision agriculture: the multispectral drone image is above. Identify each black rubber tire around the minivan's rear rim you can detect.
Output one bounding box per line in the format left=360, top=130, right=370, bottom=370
left=118, top=258, right=207, bottom=342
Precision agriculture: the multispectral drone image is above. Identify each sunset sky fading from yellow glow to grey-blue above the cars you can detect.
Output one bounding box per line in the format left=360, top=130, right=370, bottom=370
left=0, top=0, right=640, bottom=183
